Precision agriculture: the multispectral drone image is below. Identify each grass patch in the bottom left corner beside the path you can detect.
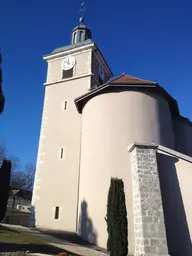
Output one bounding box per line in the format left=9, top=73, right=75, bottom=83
left=0, top=225, right=75, bottom=256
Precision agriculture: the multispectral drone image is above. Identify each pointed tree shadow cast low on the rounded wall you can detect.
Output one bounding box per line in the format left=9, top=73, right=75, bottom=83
left=78, top=201, right=97, bottom=245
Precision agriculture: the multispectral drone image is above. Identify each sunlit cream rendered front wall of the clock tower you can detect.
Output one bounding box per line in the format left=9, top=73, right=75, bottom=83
left=32, top=50, right=92, bottom=231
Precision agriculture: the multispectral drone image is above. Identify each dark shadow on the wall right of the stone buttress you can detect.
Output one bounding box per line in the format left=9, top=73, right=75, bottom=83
left=157, top=153, right=192, bottom=256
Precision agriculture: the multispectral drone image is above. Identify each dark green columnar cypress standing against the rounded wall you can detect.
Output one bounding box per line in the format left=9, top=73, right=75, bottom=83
left=106, top=178, right=128, bottom=256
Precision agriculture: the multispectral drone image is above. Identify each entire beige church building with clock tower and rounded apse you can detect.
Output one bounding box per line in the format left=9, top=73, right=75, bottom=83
left=30, top=18, right=192, bottom=256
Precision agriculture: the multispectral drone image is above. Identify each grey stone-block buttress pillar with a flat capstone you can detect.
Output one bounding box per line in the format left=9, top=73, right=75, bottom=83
left=129, top=143, right=169, bottom=256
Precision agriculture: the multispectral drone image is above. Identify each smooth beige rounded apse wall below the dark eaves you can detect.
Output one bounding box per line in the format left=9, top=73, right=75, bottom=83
left=79, top=91, right=174, bottom=247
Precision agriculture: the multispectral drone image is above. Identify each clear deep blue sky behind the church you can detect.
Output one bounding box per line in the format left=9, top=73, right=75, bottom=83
left=0, top=0, right=192, bottom=164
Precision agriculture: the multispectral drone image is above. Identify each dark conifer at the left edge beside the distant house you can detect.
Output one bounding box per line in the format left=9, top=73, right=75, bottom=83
left=0, top=160, right=11, bottom=221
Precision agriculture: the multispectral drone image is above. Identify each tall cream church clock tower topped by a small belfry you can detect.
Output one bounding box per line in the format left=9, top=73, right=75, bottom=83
left=30, top=5, right=112, bottom=232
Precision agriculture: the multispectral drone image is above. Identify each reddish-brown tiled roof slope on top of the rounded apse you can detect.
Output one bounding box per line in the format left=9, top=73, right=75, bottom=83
left=109, top=73, right=156, bottom=85
